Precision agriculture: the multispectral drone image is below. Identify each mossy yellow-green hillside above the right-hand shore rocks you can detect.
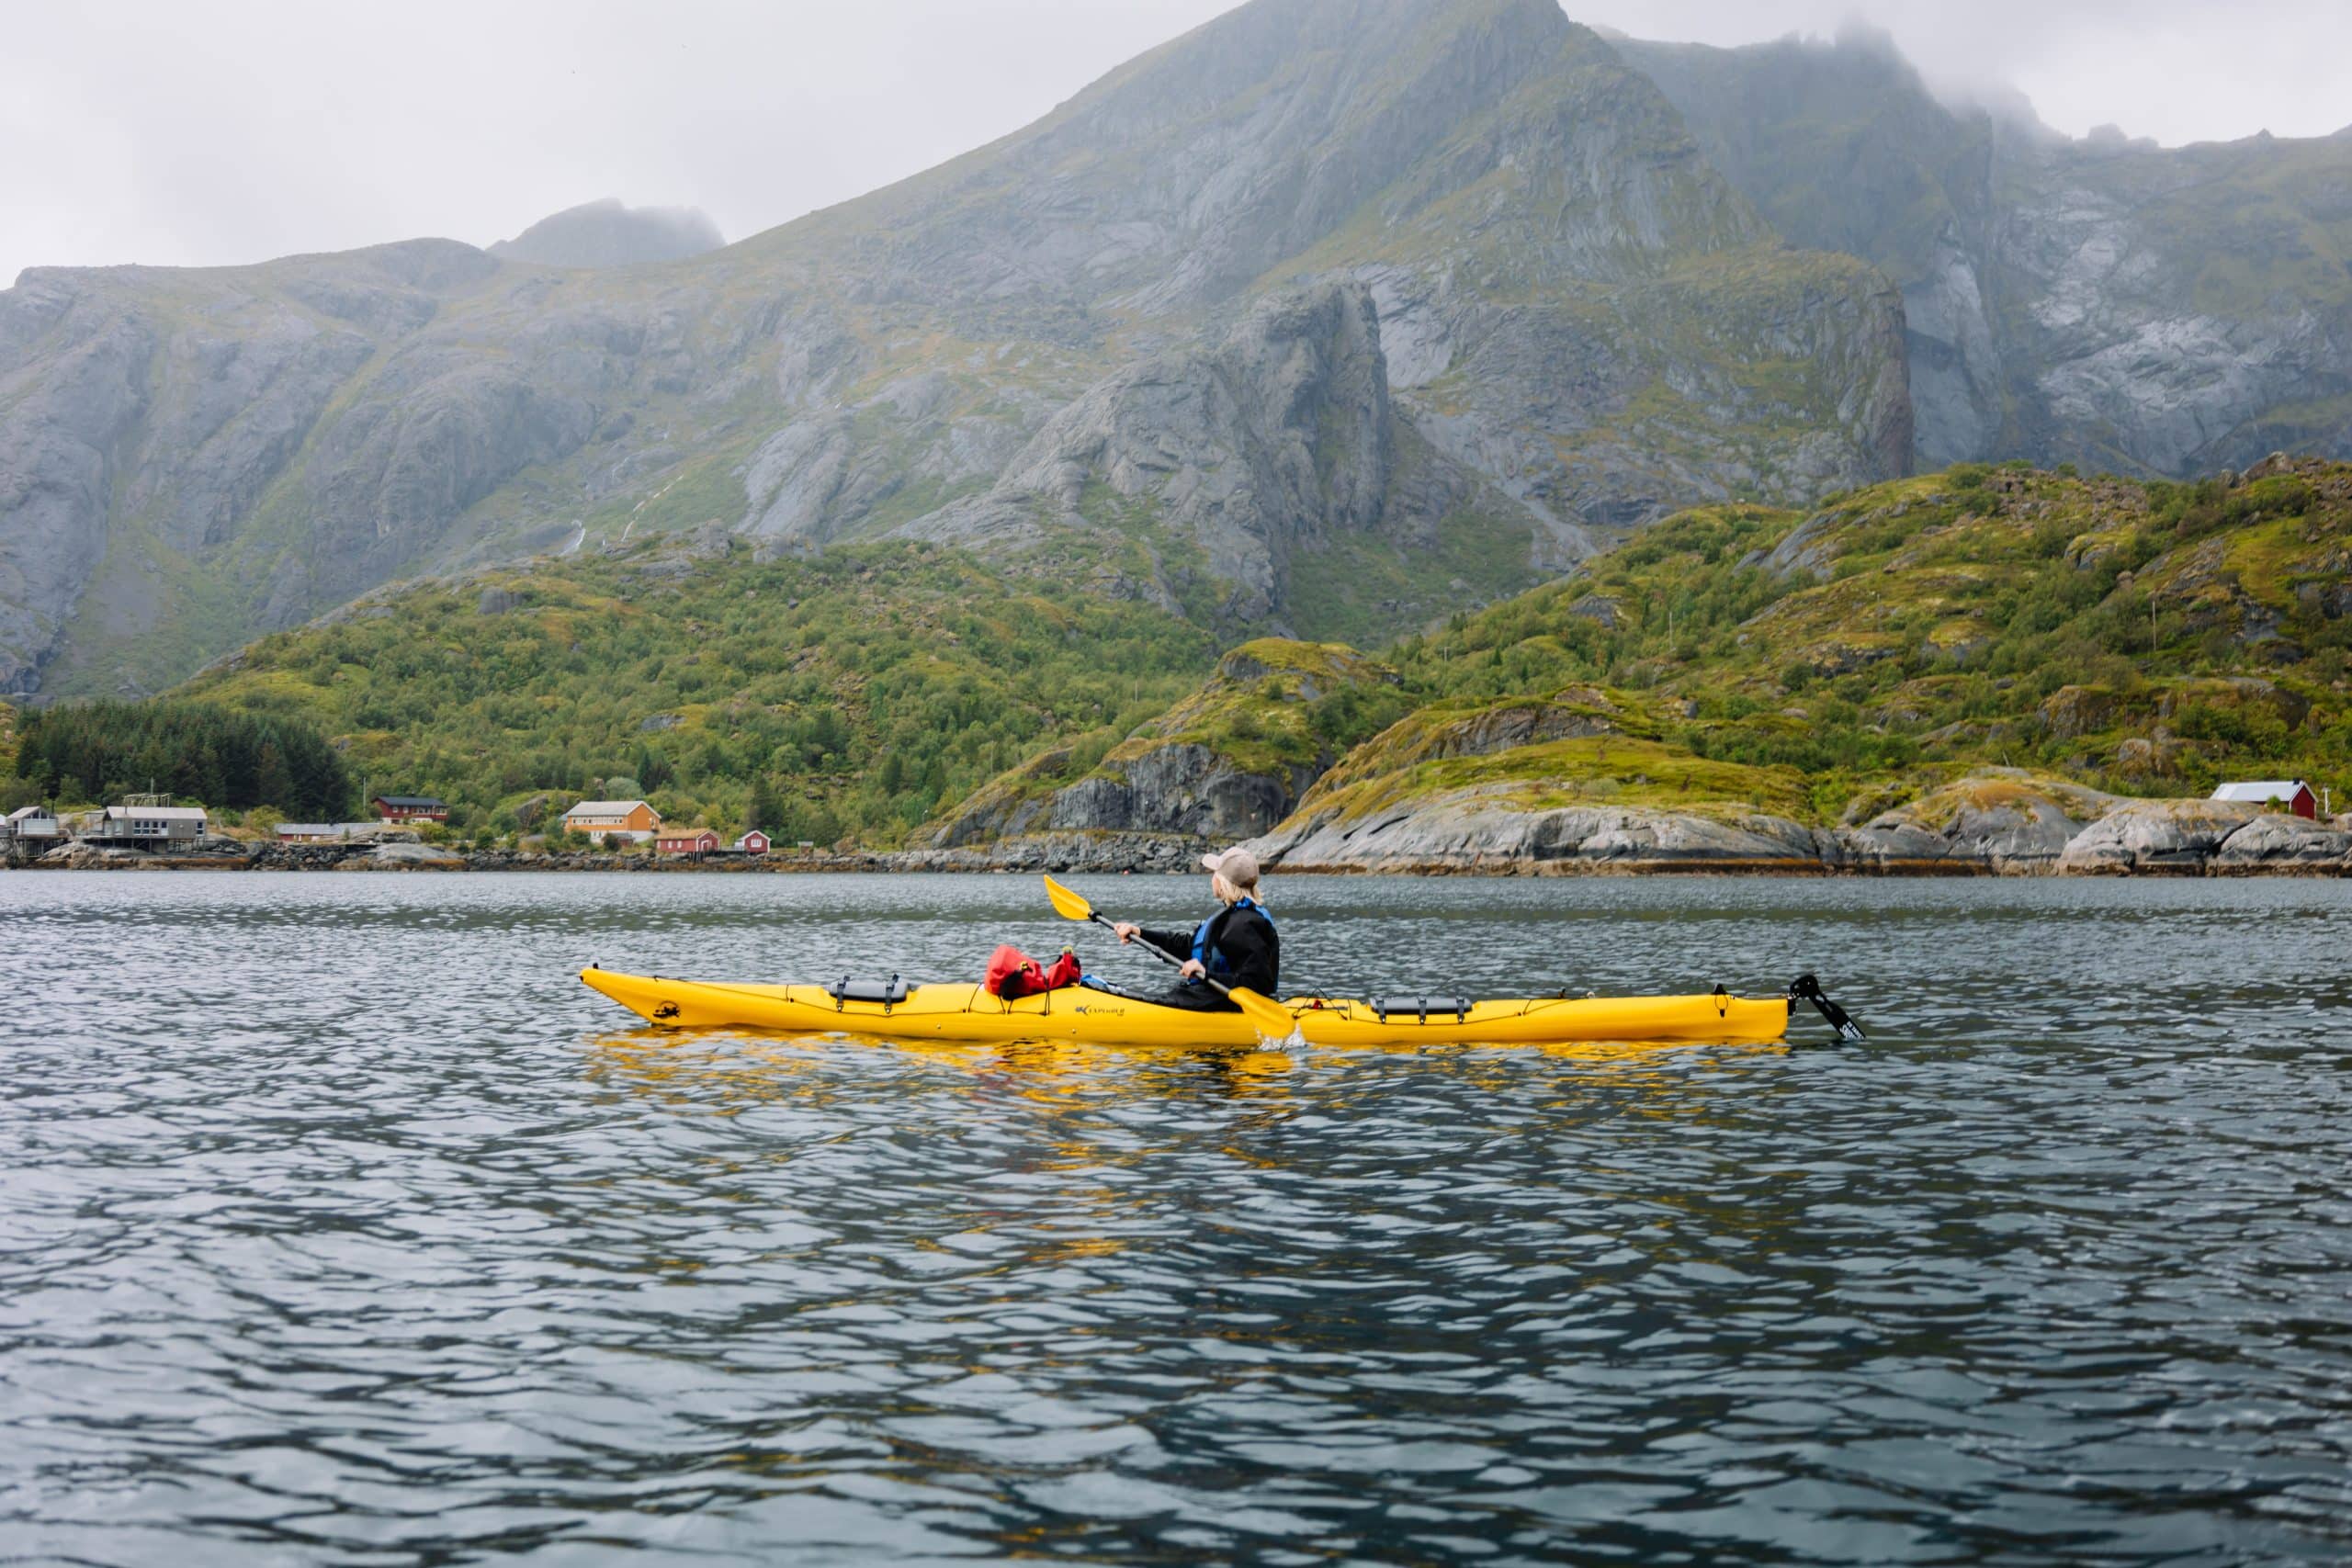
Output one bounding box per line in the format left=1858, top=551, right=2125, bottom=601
left=1279, top=453, right=2352, bottom=820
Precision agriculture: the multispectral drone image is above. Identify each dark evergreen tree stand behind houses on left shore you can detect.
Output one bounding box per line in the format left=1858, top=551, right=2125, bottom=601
left=14, top=698, right=353, bottom=820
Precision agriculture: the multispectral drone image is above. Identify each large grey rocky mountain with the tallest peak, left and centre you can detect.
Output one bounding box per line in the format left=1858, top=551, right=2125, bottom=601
left=0, top=0, right=1912, bottom=696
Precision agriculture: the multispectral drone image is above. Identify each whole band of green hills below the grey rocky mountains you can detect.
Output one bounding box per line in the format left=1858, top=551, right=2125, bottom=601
left=86, top=461, right=2352, bottom=846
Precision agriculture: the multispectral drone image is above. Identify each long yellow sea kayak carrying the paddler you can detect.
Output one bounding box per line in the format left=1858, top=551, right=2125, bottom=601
left=581, top=966, right=1790, bottom=1046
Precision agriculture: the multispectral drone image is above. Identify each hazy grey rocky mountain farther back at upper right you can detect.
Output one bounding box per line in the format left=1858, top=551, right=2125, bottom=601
left=1618, top=30, right=2352, bottom=475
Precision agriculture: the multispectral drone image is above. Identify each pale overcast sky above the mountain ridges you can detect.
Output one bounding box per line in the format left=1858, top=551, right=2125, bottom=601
left=0, top=0, right=2352, bottom=282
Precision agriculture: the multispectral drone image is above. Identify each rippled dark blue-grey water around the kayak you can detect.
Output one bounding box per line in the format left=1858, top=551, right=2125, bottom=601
left=0, top=872, right=2352, bottom=1568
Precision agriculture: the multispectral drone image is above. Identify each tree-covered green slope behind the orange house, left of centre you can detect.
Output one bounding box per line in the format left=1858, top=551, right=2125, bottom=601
left=181, top=538, right=1214, bottom=844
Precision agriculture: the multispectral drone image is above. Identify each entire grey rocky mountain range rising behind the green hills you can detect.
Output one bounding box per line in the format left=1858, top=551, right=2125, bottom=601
left=0, top=0, right=2352, bottom=696
